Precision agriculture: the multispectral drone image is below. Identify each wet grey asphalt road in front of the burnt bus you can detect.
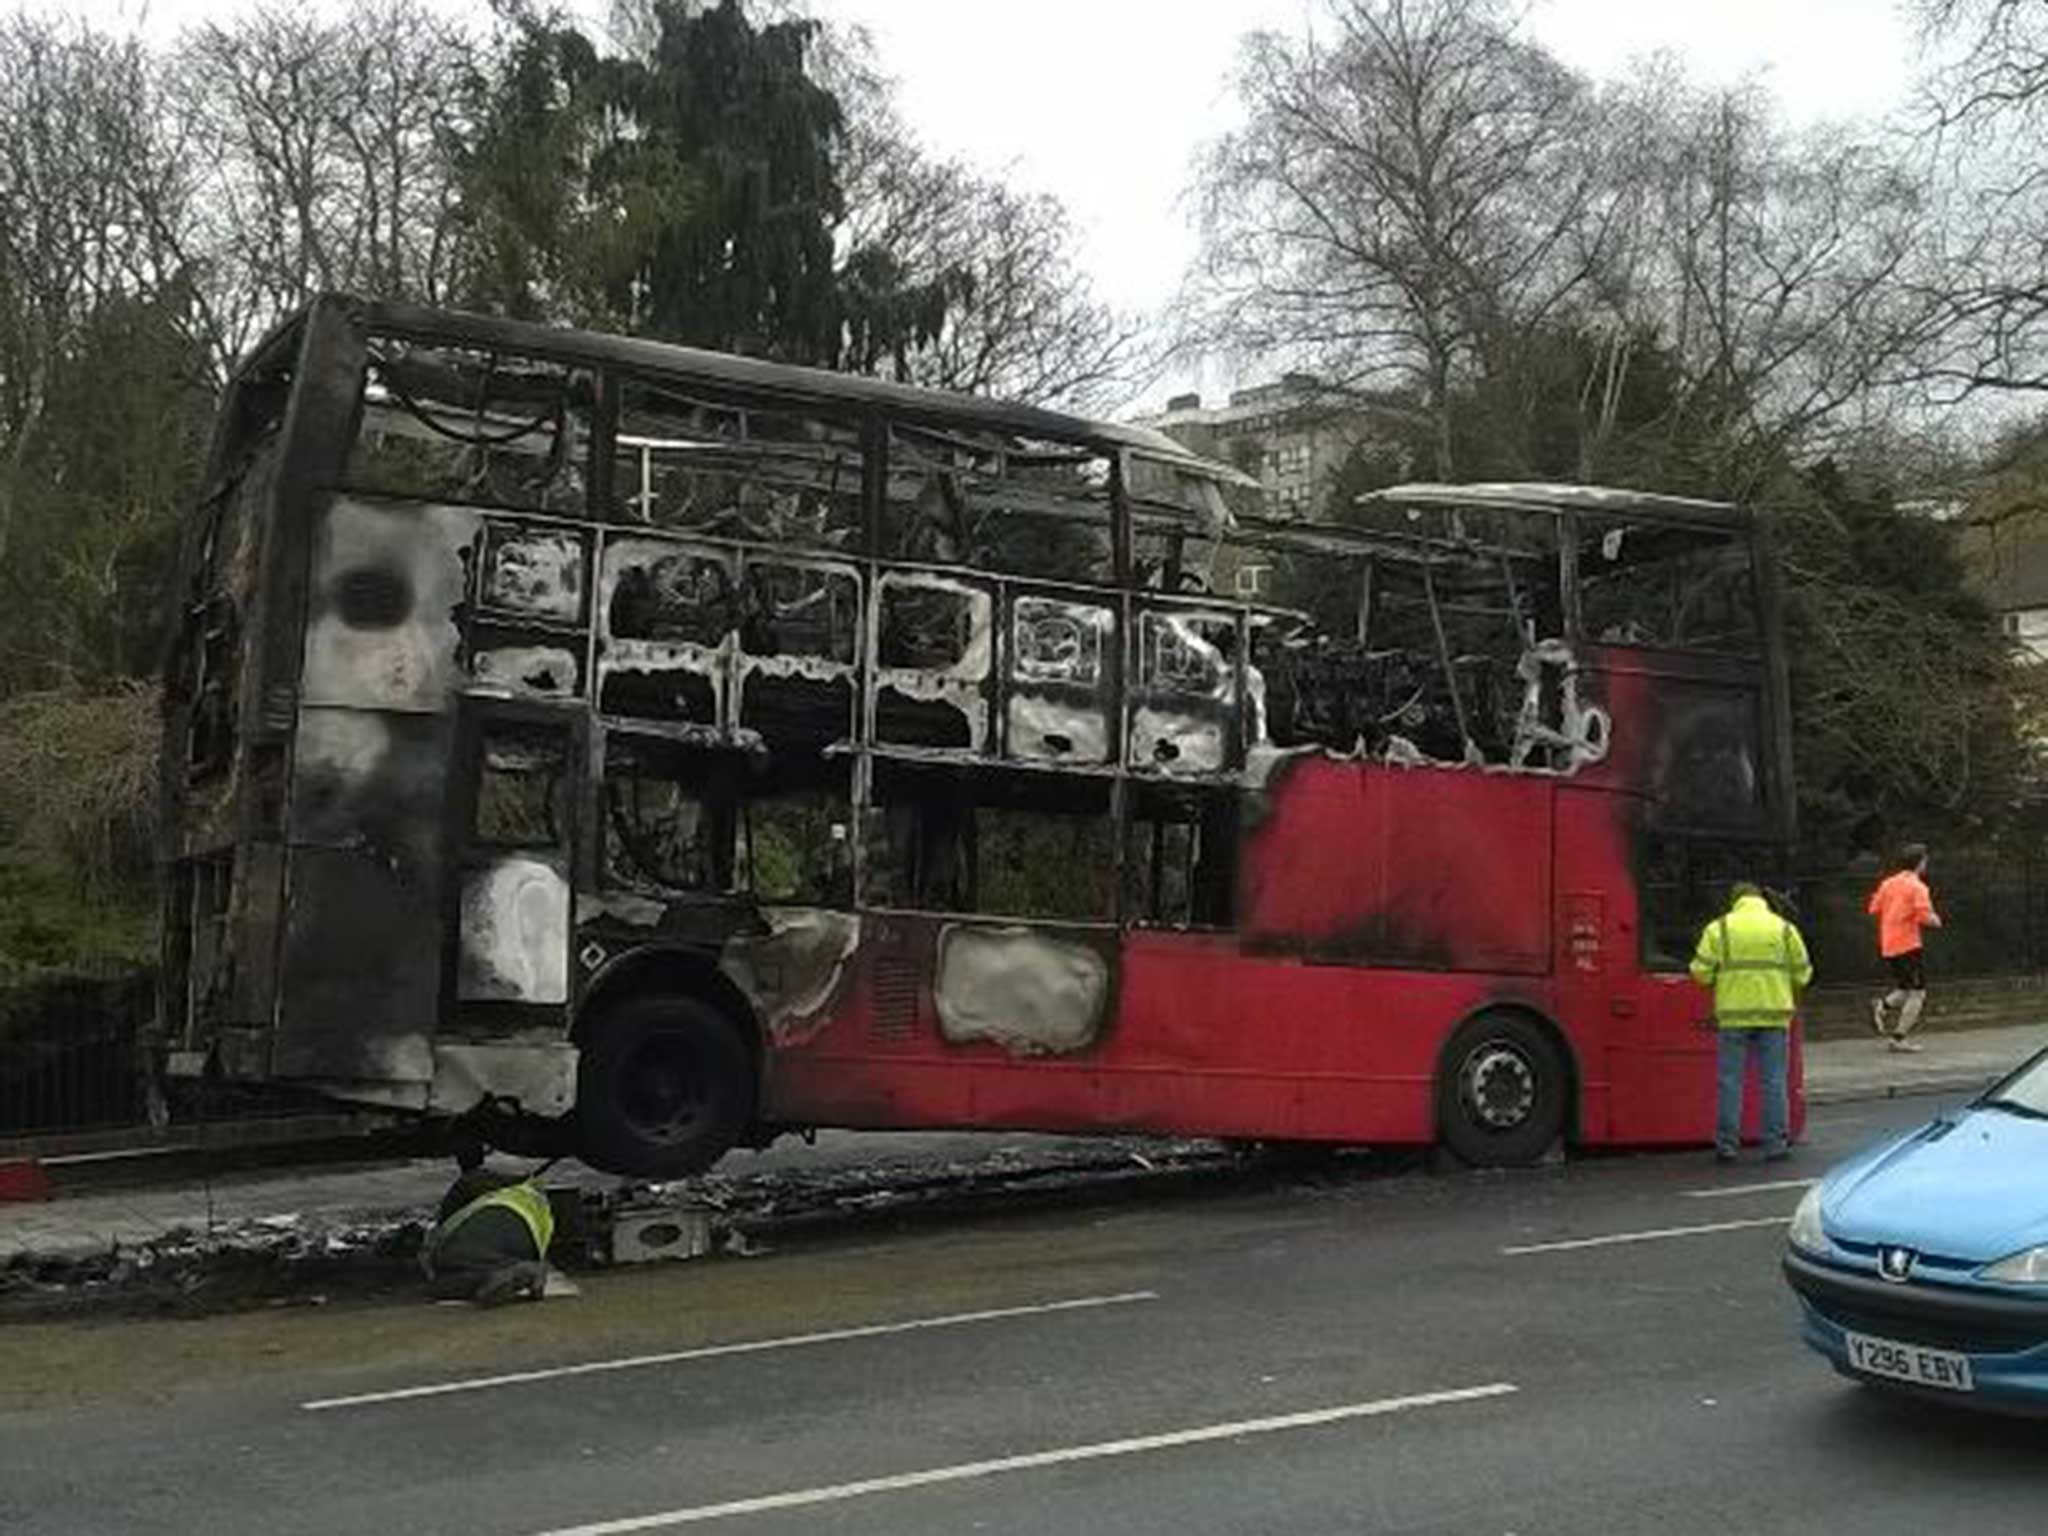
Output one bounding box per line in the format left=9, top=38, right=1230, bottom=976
left=0, top=1098, right=2048, bottom=1536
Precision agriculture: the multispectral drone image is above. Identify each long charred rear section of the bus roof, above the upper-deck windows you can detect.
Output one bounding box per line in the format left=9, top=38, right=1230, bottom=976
left=242, top=293, right=1255, bottom=483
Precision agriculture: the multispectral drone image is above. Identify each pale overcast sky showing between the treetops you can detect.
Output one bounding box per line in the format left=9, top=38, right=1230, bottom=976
left=59, top=0, right=1915, bottom=403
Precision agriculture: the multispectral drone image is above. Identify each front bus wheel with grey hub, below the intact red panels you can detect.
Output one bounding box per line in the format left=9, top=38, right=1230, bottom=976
left=1436, top=1012, right=1571, bottom=1167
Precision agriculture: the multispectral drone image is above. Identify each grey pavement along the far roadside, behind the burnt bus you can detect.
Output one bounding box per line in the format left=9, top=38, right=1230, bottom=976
left=0, top=1024, right=2048, bottom=1266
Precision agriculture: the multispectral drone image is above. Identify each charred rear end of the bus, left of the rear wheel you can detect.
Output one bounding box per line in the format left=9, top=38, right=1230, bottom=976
left=162, top=299, right=584, bottom=1122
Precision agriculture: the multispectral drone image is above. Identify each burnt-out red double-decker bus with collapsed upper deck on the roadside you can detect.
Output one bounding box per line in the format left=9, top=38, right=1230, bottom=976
left=164, top=297, right=1796, bottom=1176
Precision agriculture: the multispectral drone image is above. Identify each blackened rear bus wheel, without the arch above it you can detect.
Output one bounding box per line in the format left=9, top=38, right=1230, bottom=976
left=575, top=995, right=754, bottom=1178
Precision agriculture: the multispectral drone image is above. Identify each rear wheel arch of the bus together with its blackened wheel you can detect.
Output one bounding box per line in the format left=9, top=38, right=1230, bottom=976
left=575, top=950, right=762, bottom=1178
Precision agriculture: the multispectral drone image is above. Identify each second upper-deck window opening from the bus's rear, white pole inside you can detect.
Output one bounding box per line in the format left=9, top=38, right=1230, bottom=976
left=612, top=379, right=864, bottom=553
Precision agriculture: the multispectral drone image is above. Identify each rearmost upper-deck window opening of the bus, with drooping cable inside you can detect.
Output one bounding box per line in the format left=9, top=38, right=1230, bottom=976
left=344, top=340, right=594, bottom=514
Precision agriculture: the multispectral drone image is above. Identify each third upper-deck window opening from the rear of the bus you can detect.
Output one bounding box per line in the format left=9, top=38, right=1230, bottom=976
left=881, top=424, right=1116, bottom=586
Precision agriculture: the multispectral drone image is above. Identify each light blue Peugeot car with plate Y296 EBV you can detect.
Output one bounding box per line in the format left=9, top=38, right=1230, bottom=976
left=1784, top=1051, right=2048, bottom=1411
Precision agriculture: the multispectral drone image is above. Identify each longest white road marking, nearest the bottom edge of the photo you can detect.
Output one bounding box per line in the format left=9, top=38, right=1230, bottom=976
left=543, top=1380, right=1516, bottom=1536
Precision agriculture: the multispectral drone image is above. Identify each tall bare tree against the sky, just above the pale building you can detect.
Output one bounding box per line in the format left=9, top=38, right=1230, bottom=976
left=1184, top=0, right=1602, bottom=475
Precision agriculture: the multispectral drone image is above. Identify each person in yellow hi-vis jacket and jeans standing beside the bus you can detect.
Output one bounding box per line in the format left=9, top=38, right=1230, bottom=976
left=1692, top=881, right=1812, bottom=1163
